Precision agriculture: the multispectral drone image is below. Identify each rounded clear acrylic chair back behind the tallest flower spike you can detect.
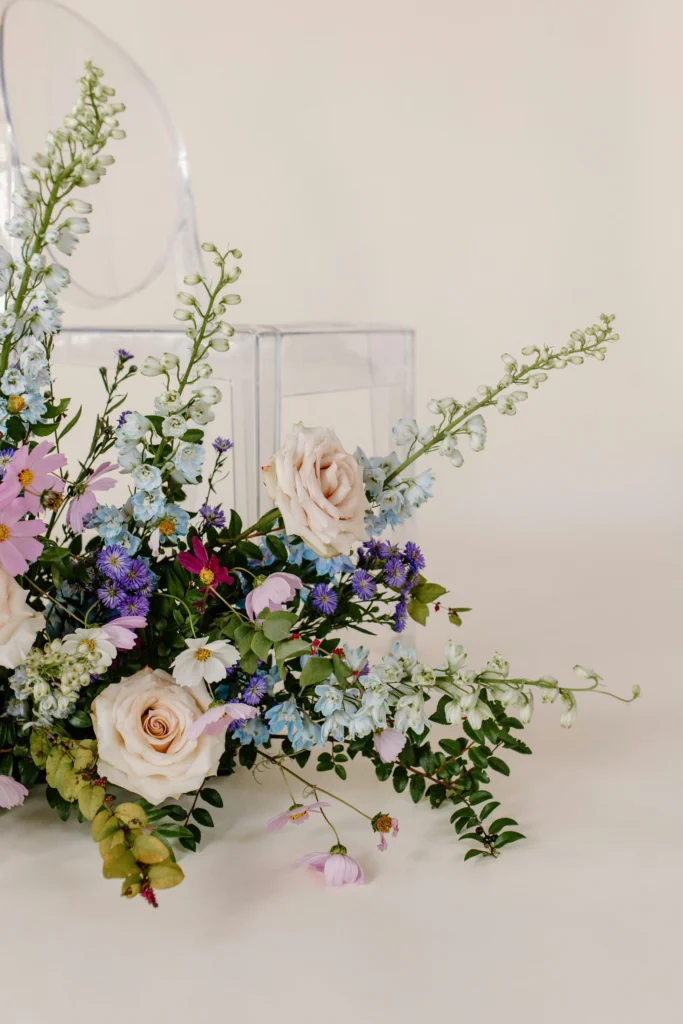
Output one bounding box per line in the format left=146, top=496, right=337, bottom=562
left=0, top=0, right=202, bottom=308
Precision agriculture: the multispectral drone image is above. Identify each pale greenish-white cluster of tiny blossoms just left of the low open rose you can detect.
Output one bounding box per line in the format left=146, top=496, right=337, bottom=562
left=8, top=638, right=102, bottom=725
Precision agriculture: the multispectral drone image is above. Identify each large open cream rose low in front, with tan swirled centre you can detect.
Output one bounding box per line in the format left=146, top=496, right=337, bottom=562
left=92, top=669, right=225, bottom=804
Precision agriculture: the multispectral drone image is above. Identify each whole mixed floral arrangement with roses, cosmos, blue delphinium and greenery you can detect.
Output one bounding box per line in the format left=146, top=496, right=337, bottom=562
left=0, top=63, right=638, bottom=906
